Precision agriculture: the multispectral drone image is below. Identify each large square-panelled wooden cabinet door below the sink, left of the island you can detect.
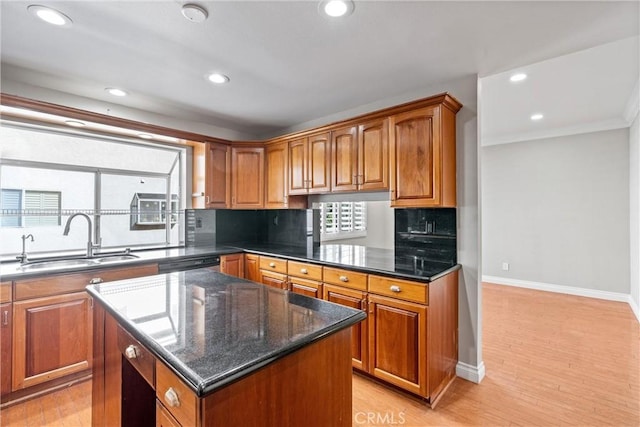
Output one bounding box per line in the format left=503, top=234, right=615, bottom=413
left=13, top=292, right=93, bottom=391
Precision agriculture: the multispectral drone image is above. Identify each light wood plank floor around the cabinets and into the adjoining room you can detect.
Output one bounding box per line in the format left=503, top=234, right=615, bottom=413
left=0, top=284, right=640, bottom=427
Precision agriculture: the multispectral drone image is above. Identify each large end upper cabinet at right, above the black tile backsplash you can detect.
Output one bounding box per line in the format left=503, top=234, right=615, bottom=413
left=389, top=99, right=461, bottom=207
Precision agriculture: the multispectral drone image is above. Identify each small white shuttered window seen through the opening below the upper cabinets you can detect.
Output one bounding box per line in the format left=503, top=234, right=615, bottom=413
left=319, top=202, right=367, bottom=240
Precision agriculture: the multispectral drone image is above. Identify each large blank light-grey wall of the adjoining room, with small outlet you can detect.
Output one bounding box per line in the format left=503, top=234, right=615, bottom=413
left=481, top=129, right=629, bottom=299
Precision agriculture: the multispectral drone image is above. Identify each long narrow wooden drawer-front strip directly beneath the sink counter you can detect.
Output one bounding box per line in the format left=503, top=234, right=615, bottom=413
left=14, top=264, right=158, bottom=300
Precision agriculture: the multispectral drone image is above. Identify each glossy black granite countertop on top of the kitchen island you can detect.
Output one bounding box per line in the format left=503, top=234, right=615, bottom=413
left=87, top=269, right=366, bottom=396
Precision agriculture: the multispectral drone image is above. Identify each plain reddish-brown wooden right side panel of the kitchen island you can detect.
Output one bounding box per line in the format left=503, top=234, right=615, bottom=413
left=202, top=329, right=352, bottom=427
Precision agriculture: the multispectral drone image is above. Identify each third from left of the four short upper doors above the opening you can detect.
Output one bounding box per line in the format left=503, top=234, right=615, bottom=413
left=331, top=126, right=359, bottom=191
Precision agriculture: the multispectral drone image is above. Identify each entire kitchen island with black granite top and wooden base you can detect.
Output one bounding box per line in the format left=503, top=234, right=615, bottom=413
left=87, top=269, right=366, bottom=426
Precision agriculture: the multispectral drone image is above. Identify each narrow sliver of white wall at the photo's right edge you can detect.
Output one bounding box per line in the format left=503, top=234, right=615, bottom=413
left=629, top=115, right=640, bottom=320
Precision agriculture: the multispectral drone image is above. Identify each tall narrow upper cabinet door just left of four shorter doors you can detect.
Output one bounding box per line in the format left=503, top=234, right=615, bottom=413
left=264, top=142, right=289, bottom=209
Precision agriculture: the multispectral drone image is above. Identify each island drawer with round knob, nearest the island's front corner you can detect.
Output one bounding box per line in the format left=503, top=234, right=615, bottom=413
left=156, top=360, right=198, bottom=426
